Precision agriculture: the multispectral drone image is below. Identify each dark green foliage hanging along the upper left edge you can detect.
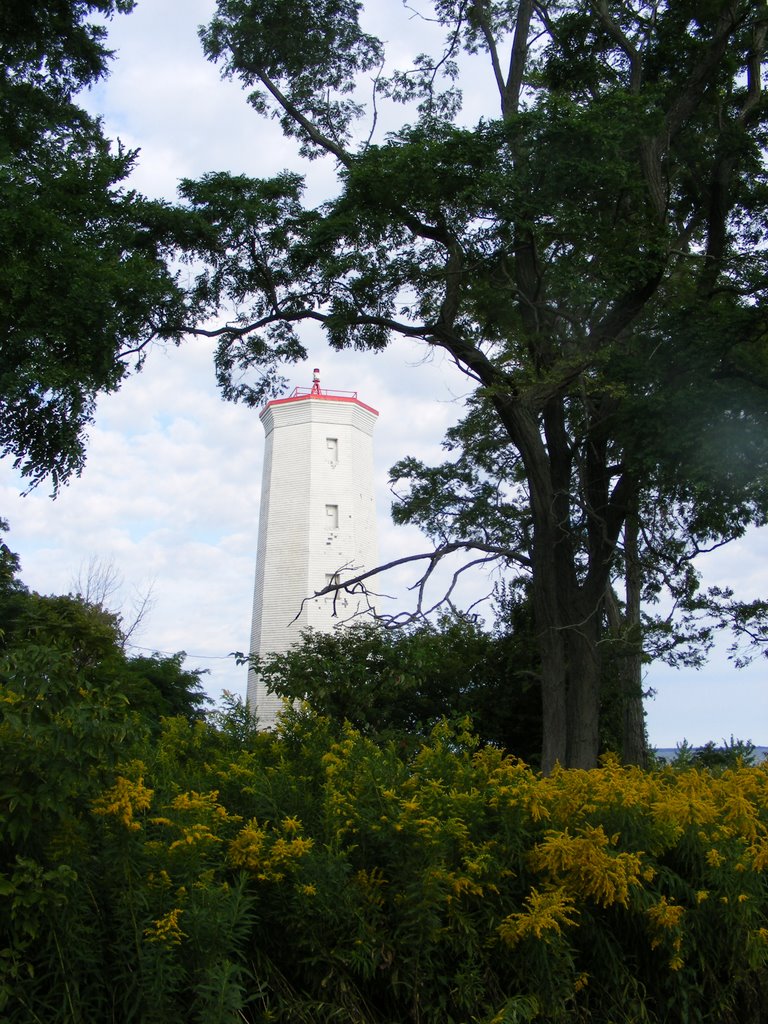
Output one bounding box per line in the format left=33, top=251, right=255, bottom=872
left=0, top=0, right=198, bottom=493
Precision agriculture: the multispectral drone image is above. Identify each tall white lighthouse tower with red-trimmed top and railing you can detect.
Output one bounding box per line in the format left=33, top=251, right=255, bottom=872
left=248, top=370, right=379, bottom=729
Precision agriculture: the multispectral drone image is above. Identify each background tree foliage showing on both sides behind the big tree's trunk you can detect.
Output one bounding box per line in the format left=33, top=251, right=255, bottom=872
left=390, top=387, right=753, bottom=764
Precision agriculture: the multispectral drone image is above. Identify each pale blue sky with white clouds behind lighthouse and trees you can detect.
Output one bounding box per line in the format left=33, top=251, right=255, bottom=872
left=0, top=0, right=768, bottom=748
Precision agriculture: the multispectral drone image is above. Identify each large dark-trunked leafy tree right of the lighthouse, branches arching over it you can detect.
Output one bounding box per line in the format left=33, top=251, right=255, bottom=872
left=181, top=0, right=768, bottom=769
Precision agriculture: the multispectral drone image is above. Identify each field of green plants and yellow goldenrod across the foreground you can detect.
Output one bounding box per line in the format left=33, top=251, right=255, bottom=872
left=0, top=664, right=768, bottom=1024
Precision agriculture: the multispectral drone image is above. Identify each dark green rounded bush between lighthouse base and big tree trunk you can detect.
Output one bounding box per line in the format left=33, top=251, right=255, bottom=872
left=254, top=605, right=542, bottom=764
